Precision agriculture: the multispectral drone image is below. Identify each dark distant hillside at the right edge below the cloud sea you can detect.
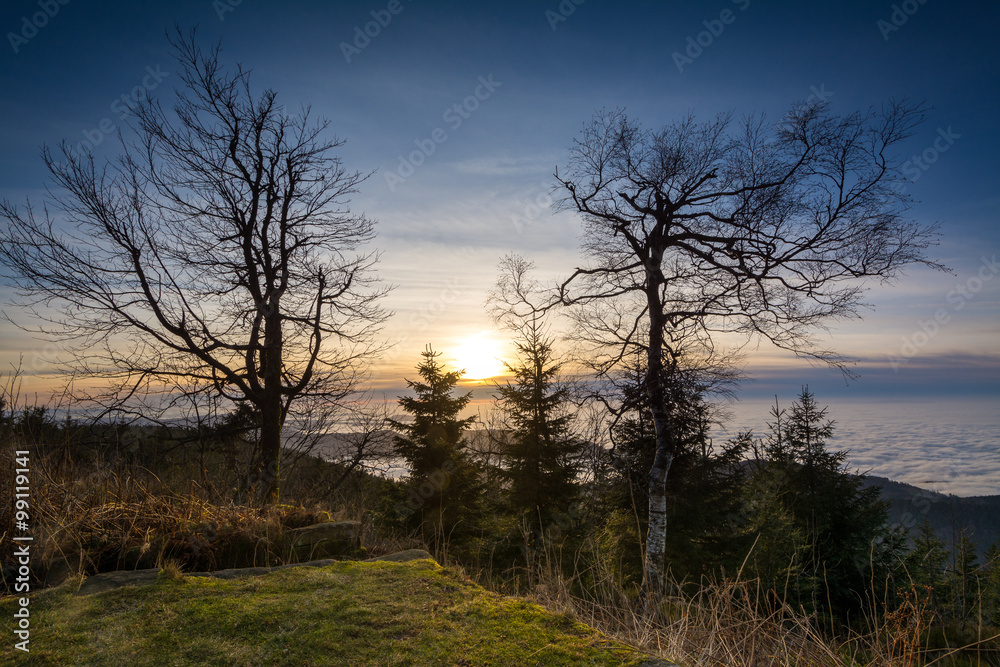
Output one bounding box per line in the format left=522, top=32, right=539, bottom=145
left=865, top=477, right=1000, bottom=562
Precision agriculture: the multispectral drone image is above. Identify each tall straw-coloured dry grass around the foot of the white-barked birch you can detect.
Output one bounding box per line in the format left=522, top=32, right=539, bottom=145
left=470, top=536, right=1000, bottom=667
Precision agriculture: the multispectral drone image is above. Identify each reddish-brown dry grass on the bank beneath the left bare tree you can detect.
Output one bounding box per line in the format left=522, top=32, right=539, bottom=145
left=0, top=442, right=350, bottom=584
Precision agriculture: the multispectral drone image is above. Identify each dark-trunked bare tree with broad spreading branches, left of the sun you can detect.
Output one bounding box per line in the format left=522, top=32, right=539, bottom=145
left=0, top=29, right=386, bottom=499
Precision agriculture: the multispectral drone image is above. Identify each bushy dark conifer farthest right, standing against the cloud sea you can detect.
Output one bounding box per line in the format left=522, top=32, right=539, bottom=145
left=748, top=388, right=903, bottom=620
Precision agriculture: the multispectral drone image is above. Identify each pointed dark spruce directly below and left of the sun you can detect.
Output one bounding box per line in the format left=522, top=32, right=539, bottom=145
left=391, top=345, right=481, bottom=541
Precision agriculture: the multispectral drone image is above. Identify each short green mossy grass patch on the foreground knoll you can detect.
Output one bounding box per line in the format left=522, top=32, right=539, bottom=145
left=0, top=560, right=668, bottom=667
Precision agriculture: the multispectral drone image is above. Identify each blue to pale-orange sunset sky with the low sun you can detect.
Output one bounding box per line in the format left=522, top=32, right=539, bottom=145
left=0, top=0, right=1000, bottom=490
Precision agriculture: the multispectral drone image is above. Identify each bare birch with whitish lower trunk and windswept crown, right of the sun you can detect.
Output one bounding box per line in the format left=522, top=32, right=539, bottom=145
left=556, top=103, right=942, bottom=604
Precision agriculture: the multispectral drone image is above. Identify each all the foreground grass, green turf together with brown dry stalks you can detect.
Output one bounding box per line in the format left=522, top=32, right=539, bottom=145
left=0, top=387, right=1000, bottom=667
